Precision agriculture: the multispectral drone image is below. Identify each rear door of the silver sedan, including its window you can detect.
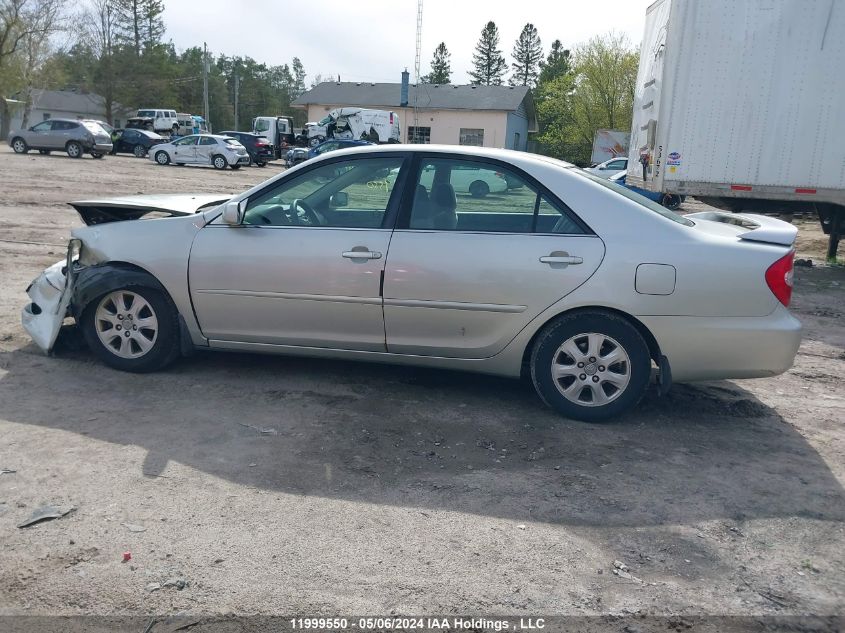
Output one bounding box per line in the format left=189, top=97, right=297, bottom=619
left=384, top=154, right=604, bottom=358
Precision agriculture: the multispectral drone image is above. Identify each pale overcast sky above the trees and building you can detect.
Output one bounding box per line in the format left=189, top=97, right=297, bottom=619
left=164, top=0, right=654, bottom=85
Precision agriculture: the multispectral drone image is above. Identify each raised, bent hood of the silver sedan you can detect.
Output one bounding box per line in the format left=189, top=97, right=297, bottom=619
left=68, top=193, right=232, bottom=226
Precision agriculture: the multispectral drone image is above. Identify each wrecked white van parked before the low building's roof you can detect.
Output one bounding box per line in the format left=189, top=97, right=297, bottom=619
left=305, top=108, right=401, bottom=147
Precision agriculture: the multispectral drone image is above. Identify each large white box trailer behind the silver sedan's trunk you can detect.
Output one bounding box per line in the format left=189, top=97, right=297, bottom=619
left=627, top=0, right=845, bottom=258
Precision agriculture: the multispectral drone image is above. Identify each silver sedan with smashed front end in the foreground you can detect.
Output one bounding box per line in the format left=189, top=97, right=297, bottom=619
left=23, top=145, right=801, bottom=420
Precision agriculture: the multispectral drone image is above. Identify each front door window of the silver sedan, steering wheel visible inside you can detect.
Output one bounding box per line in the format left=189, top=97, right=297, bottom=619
left=244, top=157, right=403, bottom=228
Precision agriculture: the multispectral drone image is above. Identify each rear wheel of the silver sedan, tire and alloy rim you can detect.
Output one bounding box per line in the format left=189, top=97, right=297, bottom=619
left=531, top=310, right=651, bottom=422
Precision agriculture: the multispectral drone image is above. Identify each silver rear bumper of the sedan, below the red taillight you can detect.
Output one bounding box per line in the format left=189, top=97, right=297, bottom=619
left=639, top=304, right=801, bottom=382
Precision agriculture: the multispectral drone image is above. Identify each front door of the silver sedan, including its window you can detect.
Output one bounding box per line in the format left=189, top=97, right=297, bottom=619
left=189, top=153, right=405, bottom=352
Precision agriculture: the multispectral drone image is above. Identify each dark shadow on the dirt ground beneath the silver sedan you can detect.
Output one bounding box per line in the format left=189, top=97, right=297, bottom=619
left=0, top=338, right=845, bottom=526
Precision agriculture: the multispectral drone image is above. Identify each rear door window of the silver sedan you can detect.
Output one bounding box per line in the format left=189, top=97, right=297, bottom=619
left=408, top=158, right=584, bottom=234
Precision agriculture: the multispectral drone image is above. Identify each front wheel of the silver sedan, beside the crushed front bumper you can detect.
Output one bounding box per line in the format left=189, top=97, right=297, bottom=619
left=81, top=285, right=180, bottom=373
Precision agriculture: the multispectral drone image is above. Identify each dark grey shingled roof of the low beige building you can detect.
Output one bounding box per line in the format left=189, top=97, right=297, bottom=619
left=292, top=81, right=534, bottom=113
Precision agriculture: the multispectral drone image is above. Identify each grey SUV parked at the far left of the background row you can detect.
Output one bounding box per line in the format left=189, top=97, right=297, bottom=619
left=9, top=119, right=112, bottom=158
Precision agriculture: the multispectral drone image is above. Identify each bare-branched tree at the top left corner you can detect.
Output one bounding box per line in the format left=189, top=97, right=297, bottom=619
left=0, top=0, right=65, bottom=137
